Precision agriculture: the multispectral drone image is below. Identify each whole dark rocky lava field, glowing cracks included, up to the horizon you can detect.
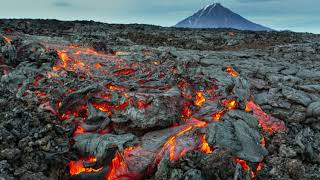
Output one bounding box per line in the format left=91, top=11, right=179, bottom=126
left=0, top=20, right=320, bottom=180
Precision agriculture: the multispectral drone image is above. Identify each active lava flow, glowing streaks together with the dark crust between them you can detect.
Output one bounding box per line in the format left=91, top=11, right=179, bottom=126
left=15, top=42, right=284, bottom=180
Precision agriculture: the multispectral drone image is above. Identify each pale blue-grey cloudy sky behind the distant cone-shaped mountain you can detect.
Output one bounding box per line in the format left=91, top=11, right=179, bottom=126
left=0, top=0, right=320, bottom=33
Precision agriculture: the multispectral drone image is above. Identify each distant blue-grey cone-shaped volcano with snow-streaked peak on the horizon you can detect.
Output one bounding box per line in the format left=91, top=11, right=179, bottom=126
left=175, top=3, right=272, bottom=31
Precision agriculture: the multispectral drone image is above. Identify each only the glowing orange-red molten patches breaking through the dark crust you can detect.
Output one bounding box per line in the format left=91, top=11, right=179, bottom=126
left=19, top=45, right=285, bottom=180
